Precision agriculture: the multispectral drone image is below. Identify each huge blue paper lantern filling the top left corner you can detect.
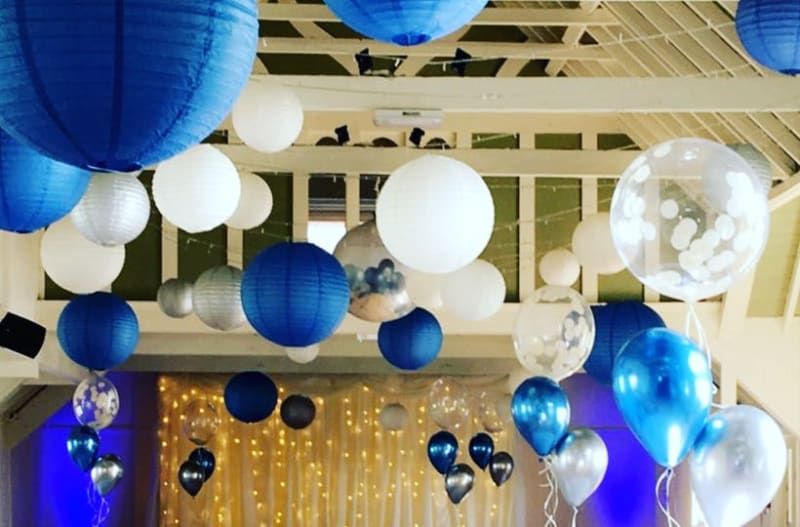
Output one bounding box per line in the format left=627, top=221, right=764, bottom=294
left=0, top=0, right=258, bottom=172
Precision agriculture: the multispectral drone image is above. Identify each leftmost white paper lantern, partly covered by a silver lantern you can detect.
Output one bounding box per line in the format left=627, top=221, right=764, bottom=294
left=41, top=218, right=125, bottom=294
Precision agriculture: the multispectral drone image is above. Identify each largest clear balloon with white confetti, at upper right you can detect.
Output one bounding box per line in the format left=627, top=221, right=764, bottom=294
left=611, top=138, right=769, bottom=302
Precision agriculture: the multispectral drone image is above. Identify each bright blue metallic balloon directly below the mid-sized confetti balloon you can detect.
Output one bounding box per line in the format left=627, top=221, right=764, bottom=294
left=511, top=377, right=569, bottom=456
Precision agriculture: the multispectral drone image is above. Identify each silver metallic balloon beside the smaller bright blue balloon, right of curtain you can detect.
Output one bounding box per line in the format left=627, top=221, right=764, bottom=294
left=551, top=428, right=608, bottom=507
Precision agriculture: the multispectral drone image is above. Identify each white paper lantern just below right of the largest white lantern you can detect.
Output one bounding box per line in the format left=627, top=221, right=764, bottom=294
left=442, top=260, right=506, bottom=320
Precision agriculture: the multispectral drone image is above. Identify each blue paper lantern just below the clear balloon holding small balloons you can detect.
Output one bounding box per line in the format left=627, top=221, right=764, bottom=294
left=378, top=307, right=442, bottom=370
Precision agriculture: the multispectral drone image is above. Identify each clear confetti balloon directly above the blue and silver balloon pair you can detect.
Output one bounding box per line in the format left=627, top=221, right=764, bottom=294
left=513, top=285, right=594, bottom=381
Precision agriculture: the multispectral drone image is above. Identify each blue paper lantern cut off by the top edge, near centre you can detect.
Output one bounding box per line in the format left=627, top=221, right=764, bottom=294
left=325, top=0, right=486, bottom=46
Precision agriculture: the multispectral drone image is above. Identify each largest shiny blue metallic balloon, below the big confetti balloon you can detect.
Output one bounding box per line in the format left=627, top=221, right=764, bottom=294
left=613, top=328, right=713, bottom=467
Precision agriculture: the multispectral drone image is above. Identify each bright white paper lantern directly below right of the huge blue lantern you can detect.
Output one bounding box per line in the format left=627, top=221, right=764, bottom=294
left=153, top=145, right=242, bottom=233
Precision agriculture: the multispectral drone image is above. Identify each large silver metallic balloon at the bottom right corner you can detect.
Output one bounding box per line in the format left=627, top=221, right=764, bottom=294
left=689, top=405, right=787, bottom=527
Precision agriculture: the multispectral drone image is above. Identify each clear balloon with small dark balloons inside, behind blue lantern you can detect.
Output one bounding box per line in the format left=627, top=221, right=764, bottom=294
left=333, top=221, right=414, bottom=322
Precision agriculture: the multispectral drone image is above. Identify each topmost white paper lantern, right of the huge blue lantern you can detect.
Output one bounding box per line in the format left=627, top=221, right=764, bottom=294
left=232, top=81, right=303, bottom=153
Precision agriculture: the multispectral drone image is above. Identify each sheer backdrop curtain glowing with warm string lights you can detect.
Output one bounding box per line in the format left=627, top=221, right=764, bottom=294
left=159, top=376, right=518, bottom=527
